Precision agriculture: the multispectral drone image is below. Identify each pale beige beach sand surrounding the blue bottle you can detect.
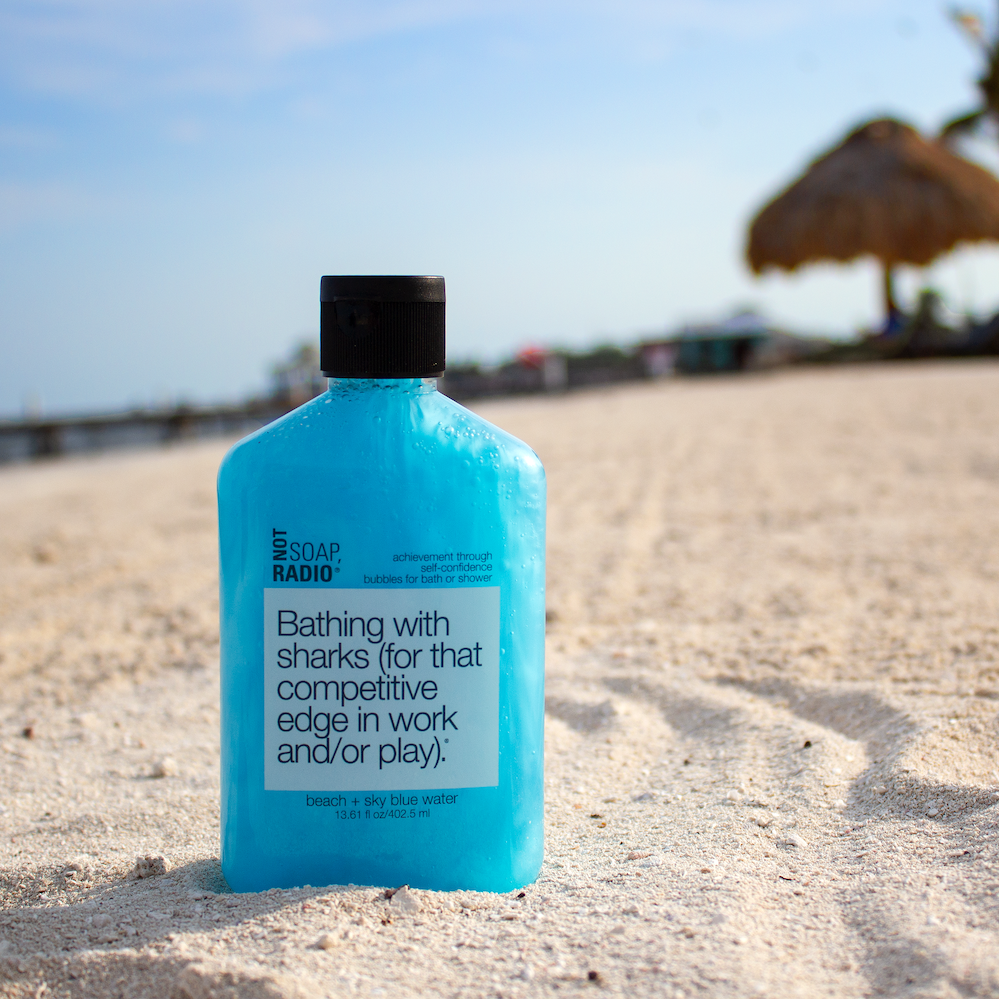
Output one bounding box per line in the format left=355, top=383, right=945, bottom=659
left=0, top=362, right=999, bottom=999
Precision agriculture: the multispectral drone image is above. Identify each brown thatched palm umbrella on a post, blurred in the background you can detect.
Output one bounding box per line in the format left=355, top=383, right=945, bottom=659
left=746, top=118, right=999, bottom=316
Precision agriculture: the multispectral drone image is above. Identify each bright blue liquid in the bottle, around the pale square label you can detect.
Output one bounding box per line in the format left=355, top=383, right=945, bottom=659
left=218, top=379, right=545, bottom=891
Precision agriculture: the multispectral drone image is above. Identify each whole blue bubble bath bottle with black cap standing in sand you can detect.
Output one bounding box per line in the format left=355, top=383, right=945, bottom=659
left=218, top=277, right=545, bottom=891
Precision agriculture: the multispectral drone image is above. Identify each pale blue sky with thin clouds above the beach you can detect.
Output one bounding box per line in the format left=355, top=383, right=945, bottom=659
left=0, top=0, right=999, bottom=417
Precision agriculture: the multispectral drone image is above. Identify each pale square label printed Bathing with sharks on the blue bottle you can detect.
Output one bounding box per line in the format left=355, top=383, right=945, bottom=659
left=264, top=586, right=500, bottom=791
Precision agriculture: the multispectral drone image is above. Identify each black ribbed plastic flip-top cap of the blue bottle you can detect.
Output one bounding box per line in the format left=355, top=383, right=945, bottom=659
left=319, top=275, right=444, bottom=378
